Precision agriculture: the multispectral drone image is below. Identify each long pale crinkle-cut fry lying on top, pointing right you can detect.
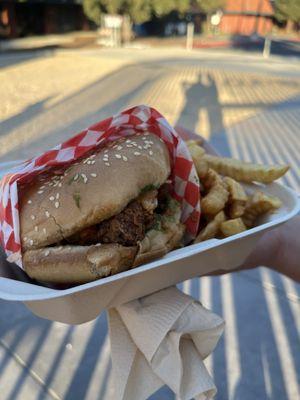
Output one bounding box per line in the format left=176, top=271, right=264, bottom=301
left=203, top=154, right=289, bottom=183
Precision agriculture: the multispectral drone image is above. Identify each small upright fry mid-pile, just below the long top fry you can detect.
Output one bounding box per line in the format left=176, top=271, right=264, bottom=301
left=223, top=176, right=248, bottom=218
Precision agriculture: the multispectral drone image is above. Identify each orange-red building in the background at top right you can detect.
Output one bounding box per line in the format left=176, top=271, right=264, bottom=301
left=219, top=0, right=274, bottom=35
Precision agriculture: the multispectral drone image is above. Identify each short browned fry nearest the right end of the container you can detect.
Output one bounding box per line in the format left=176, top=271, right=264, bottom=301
left=243, top=190, right=282, bottom=228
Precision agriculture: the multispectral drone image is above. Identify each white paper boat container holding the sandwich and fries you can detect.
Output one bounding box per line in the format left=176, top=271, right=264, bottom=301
left=0, top=159, right=300, bottom=324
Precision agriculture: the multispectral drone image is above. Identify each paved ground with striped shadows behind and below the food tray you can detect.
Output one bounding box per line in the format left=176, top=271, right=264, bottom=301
left=0, top=50, right=300, bottom=400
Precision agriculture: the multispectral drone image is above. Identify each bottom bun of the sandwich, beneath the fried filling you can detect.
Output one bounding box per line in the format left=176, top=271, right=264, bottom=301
left=23, top=203, right=185, bottom=284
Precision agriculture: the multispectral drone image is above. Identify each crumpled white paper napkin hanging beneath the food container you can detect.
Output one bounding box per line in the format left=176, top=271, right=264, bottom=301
left=109, top=287, right=224, bottom=400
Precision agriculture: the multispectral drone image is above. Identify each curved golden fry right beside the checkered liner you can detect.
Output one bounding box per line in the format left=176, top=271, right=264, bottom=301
left=201, top=169, right=229, bottom=216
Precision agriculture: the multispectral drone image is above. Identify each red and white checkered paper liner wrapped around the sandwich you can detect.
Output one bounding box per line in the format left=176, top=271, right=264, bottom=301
left=0, top=105, right=200, bottom=268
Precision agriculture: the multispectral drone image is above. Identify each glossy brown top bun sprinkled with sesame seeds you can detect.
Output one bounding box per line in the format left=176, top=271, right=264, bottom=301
left=20, top=133, right=170, bottom=251
